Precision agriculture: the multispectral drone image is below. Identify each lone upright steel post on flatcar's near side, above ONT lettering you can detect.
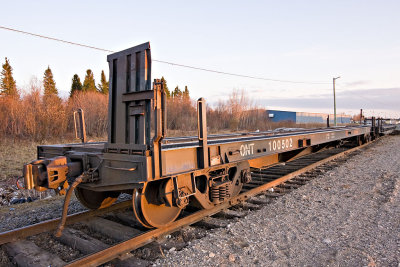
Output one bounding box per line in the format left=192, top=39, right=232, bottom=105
left=197, top=98, right=209, bottom=168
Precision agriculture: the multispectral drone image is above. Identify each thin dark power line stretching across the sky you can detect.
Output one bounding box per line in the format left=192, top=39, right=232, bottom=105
left=0, top=26, right=330, bottom=84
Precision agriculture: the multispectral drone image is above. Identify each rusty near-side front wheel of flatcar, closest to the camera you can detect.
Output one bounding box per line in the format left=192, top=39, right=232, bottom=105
left=132, top=179, right=181, bottom=228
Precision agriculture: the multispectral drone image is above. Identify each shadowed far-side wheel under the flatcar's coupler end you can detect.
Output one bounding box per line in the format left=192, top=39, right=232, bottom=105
left=75, top=187, right=120, bottom=210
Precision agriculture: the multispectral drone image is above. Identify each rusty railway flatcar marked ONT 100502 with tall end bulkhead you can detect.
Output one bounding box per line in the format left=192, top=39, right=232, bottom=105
left=24, top=43, right=379, bottom=228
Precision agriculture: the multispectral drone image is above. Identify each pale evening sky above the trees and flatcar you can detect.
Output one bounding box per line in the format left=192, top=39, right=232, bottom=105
left=0, top=0, right=400, bottom=117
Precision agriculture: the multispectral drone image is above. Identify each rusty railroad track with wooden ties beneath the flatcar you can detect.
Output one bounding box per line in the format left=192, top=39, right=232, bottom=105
left=0, top=143, right=370, bottom=266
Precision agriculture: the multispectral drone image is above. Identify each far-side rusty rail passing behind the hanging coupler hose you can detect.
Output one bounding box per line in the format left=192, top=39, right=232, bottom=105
left=0, top=200, right=132, bottom=245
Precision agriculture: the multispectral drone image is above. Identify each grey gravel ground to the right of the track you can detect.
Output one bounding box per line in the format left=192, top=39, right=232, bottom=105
left=155, top=136, right=400, bottom=266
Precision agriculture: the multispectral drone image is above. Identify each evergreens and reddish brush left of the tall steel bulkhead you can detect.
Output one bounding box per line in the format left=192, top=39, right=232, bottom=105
left=0, top=58, right=108, bottom=141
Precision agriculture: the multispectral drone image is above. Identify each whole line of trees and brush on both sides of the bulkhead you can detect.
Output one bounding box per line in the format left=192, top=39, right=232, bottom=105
left=0, top=58, right=290, bottom=140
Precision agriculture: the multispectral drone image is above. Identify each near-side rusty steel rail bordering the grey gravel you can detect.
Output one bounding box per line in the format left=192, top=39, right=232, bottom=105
left=66, top=142, right=372, bottom=267
